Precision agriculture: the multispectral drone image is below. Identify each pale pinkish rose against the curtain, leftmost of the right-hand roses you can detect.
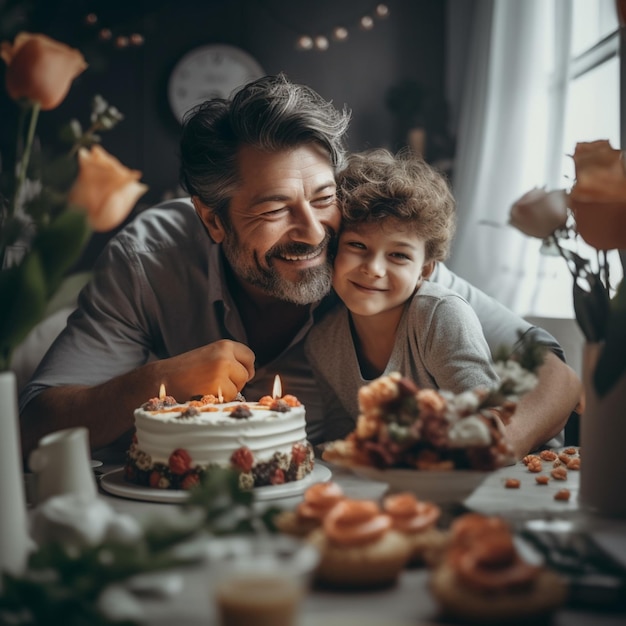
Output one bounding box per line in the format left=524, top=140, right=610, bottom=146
left=509, top=188, right=567, bottom=239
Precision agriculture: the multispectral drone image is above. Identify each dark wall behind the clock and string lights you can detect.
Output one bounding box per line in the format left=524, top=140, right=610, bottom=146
left=0, top=0, right=446, bottom=208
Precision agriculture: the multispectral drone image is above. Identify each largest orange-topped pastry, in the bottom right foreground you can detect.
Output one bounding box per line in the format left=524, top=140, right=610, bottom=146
left=429, top=513, right=567, bottom=624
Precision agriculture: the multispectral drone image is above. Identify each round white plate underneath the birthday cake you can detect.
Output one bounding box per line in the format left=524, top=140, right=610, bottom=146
left=100, top=463, right=332, bottom=503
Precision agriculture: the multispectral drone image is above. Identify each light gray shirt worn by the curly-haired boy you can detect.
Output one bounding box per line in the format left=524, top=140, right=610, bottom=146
left=305, top=281, right=498, bottom=439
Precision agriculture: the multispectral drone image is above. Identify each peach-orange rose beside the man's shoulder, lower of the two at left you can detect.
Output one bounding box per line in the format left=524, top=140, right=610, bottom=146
left=68, top=145, right=148, bottom=232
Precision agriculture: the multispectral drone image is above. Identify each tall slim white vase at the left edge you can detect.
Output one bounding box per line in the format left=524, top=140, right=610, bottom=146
left=0, top=372, right=33, bottom=588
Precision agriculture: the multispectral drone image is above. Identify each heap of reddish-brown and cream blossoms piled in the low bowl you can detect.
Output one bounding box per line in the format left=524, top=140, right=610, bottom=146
left=322, top=373, right=516, bottom=471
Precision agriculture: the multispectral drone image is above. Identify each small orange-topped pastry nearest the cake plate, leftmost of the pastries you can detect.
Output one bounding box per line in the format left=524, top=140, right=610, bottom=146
left=274, top=481, right=346, bottom=537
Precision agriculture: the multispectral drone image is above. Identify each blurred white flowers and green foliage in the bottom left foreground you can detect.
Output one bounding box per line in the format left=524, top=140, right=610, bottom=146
left=0, top=468, right=279, bottom=626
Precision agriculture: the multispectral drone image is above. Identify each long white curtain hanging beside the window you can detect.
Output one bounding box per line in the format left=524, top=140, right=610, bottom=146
left=448, top=0, right=572, bottom=316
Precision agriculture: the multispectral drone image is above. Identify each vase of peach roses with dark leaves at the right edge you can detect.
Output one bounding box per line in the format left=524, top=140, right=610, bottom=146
left=511, top=140, right=626, bottom=518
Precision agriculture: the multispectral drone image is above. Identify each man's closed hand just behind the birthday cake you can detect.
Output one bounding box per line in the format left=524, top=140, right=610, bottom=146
left=154, top=339, right=254, bottom=402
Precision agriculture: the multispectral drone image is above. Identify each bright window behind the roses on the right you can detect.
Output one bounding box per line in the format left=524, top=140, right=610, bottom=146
left=532, top=0, right=623, bottom=317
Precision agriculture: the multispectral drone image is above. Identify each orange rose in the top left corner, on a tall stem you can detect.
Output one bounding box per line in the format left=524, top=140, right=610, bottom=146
left=0, top=33, right=87, bottom=111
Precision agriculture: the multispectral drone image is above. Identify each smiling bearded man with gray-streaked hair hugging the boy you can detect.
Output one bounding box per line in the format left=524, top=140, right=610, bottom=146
left=20, top=75, right=580, bottom=455
